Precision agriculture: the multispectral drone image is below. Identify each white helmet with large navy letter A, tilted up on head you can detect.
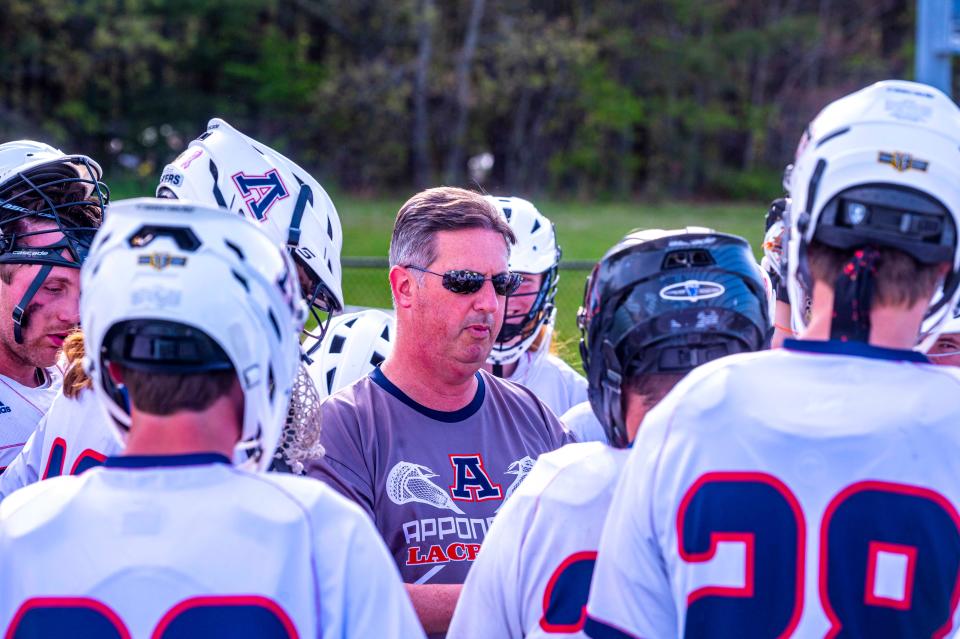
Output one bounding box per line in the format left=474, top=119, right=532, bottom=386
left=157, top=118, right=343, bottom=335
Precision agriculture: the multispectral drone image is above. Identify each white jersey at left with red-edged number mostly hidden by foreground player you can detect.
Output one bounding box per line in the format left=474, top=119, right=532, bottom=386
left=0, top=390, right=123, bottom=500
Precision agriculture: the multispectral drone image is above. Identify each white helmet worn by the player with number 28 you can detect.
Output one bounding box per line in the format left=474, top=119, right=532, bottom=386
left=787, top=80, right=960, bottom=334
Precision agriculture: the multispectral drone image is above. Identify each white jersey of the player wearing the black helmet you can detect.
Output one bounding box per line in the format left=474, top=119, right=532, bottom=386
left=447, top=442, right=628, bottom=639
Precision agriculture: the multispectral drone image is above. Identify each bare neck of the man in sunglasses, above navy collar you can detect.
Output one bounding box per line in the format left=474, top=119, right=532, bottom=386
left=380, top=342, right=477, bottom=411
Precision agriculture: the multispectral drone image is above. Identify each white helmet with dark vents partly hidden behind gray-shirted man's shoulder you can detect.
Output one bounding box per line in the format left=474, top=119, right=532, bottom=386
left=303, top=308, right=394, bottom=399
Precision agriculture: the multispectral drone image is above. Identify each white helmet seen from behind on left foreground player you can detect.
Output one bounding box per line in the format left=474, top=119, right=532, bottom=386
left=80, top=198, right=306, bottom=470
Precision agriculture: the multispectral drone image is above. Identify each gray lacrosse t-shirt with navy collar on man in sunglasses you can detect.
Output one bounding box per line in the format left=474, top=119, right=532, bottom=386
left=308, top=368, right=572, bottom=584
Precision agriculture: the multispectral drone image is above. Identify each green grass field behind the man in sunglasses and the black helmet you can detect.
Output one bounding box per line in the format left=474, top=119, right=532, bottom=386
left=333, top=194, right=766, bottom=370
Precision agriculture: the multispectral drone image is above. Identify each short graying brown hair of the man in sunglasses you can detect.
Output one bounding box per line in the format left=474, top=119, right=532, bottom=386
left=390, top=186, right=517, bottom=268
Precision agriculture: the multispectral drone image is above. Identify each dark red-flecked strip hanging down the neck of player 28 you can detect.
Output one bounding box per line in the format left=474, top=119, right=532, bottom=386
left=830, top=245, right=880, bottom=342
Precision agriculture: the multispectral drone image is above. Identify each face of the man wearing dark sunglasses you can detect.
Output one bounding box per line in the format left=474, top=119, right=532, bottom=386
left=413, top=229, right=509, bottom=372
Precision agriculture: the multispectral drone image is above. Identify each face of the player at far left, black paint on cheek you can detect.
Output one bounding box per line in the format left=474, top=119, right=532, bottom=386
left=0, top=226, right=80, bottom=368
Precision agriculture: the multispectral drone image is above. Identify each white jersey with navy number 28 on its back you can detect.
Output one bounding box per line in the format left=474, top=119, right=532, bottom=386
left=587, top=340, right=960, bottom=638
